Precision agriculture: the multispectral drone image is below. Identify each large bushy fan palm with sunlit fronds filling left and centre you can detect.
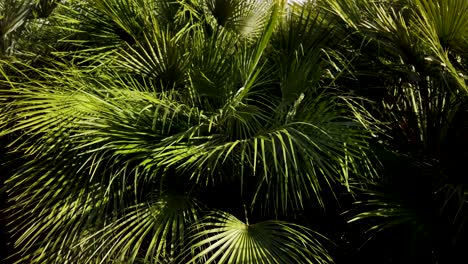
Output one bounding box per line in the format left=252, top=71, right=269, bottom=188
left=0, top=0, right=374, bottom=263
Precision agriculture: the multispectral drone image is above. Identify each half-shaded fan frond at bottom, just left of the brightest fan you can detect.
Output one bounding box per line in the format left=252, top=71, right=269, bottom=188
left=73, top=194, right=201, bottom=263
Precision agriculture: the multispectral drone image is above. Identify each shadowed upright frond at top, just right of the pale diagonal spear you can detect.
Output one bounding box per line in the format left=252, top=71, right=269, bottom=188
left=268, top=1, right=333, bottom=105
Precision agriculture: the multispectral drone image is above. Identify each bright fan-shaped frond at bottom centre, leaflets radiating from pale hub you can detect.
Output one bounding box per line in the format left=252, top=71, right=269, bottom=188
left=183, top=212, right=333, bottom=263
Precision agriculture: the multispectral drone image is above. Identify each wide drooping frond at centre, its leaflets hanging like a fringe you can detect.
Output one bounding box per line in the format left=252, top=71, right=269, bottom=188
left=149, top=92, right=367, bottom=212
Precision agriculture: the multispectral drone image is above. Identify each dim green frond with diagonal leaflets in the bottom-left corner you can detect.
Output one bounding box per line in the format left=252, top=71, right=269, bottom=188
left=7, top=182, right=109, bottom=263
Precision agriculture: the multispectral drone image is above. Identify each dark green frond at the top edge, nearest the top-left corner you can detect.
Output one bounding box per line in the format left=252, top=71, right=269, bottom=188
left=56, top=0, right=157, bottom=60
